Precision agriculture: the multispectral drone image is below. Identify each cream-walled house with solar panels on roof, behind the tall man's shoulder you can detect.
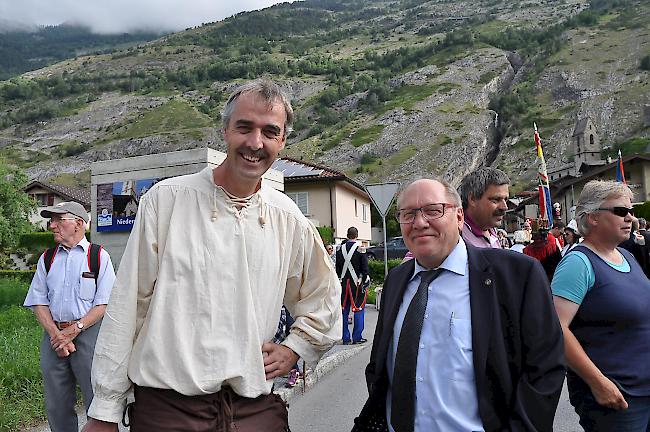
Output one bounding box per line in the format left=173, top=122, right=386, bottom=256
left=272, top=157, right=371, bottom=245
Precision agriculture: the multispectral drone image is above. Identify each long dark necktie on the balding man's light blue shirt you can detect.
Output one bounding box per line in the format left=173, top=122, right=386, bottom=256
left=390, top=269, right=442, bottom=432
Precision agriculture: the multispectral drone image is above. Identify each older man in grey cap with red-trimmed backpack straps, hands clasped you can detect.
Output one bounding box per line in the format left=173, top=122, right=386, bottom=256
left=24, top=202, right=115, bottom=432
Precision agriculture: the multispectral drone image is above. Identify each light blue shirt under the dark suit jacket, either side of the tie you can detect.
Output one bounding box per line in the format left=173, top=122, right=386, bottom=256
left=386, top=238, right=483, bottom=432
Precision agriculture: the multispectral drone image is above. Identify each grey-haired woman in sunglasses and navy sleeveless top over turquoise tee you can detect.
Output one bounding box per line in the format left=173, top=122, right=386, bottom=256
left=551, top=180, right=650, bottom=432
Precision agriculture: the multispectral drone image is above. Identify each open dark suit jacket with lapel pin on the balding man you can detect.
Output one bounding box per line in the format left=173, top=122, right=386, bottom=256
left=353, top=245, right=565, bottom=432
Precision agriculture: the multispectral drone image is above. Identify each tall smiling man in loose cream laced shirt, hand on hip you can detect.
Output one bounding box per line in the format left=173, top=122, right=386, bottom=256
left=84, top=80, right=342, bottom=432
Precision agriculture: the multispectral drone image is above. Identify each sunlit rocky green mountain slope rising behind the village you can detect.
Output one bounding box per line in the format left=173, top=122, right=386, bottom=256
left=0, top=0, right=650, bottom=189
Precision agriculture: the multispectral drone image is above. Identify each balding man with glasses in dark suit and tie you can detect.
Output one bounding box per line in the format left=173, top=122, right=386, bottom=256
left=353, top=180, right=565, bottom=432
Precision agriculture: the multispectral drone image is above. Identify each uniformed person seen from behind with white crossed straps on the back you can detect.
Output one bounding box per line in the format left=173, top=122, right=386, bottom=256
left=336, top=227, right=370, bottom=344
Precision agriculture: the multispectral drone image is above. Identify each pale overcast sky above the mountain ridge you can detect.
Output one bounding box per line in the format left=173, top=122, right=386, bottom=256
left=0, top=0, right=294, bottom=33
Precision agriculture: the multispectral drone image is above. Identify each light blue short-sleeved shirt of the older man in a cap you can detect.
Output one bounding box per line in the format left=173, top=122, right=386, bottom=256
left=23, top=237, right=115, bottom=321
